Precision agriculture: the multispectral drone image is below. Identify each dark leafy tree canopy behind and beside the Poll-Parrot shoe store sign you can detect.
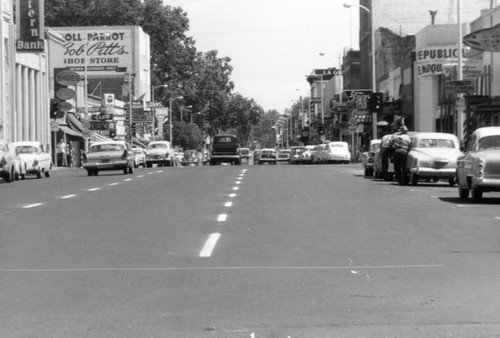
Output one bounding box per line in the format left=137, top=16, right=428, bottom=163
left=45, top=0, right=270, bottom=148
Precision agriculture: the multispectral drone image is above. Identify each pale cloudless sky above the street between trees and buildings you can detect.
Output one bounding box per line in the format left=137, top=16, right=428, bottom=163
left=163, top=0, right=359, bottom=113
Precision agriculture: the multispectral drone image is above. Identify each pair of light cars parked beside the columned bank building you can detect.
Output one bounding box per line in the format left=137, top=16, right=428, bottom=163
left=0, top=140, right=52, bottom=182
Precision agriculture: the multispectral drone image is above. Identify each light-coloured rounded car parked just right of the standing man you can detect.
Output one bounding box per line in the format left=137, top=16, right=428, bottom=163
left=401, top=133, right=463, bottom=186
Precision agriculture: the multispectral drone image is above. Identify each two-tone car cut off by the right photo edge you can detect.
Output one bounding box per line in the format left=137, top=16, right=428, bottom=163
left=456, top=127, right=500, bottom=203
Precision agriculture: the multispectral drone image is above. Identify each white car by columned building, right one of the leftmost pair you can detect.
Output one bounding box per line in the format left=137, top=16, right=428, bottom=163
left=12, top=141, right=52, bottom=179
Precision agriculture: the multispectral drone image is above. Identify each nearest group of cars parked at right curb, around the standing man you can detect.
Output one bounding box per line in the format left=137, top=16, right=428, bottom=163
left=361, top=127, right=500, bottom=203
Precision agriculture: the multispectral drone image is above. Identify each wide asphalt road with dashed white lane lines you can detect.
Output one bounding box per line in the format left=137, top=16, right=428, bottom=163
left=0, top=164, right=500, bottom=338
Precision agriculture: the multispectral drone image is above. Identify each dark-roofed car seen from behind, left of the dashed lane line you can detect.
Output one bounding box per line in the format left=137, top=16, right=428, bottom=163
left=83, top=141, right=135, bottom=176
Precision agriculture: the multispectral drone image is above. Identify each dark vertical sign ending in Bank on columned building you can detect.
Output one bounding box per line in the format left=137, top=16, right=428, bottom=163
left=16, top=0, right=45, bottom=53
